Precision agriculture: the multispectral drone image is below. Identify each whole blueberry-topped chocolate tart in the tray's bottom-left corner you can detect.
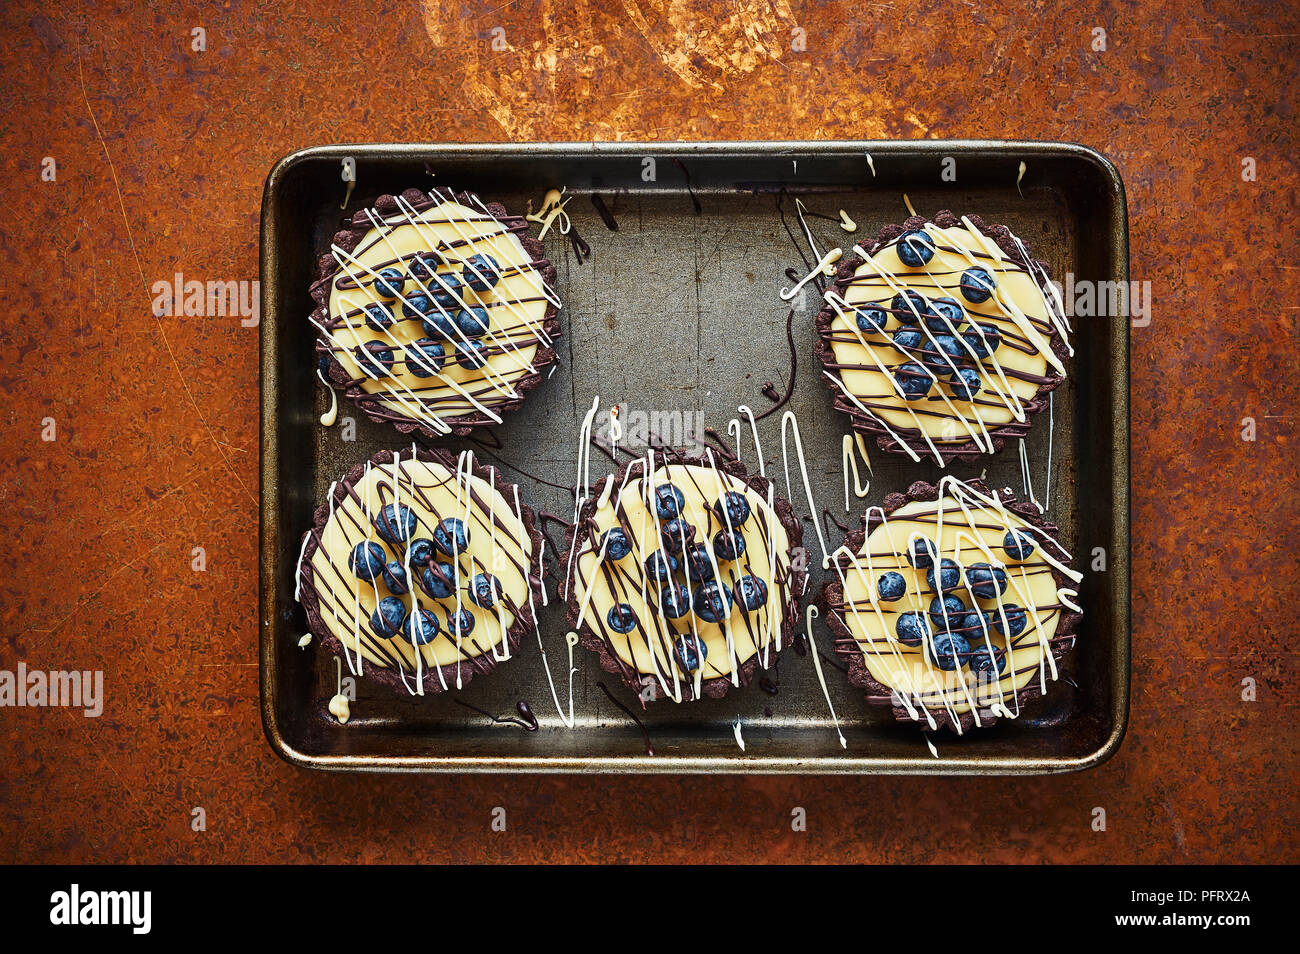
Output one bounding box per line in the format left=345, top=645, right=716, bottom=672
left=295, top=447, right=543, bottom=694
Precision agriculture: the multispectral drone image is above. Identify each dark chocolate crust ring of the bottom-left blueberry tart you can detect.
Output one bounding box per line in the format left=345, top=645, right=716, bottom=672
left=298, top=447, right=545, bottom=694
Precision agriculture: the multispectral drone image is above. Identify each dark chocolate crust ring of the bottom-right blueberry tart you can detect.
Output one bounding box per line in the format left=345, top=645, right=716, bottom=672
left=816, top=480, right=1083, bottom=734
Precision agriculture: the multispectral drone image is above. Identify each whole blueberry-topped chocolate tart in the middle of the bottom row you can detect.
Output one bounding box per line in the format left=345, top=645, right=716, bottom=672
left=560, top=451, right=807, bottom=703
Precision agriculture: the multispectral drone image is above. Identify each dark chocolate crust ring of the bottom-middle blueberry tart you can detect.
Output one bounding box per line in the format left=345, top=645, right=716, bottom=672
left=556, top=451, right=807, bottom=704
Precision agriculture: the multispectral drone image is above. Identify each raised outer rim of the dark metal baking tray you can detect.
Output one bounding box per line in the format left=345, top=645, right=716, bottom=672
left=257, top=139, right=1132, bottom=776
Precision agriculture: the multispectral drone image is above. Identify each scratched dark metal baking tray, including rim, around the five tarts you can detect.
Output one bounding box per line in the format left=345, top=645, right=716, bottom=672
left=260, top=142, right=1130, bottom=775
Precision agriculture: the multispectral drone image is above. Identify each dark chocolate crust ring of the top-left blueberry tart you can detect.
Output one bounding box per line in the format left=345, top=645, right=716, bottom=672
left=309, top=188, right=560, bottom=441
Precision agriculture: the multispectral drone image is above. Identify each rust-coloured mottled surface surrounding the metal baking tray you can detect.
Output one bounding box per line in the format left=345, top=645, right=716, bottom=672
left=0, top=0, right=1300, bottom=862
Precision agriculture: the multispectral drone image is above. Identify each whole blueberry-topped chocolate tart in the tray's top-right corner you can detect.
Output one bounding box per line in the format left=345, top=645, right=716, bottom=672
left=816, top=211, right=1073, bottom=467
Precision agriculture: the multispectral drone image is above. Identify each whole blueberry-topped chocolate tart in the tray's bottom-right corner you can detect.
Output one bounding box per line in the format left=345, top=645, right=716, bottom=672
left=818, top=477, right=1082, bottom=734
